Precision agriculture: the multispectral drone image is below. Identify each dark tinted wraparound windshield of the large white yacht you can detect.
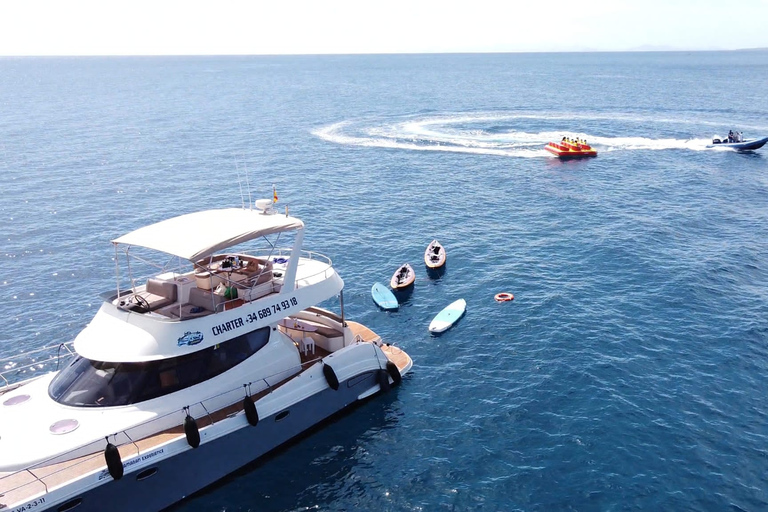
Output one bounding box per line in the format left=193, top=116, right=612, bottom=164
left=48, top=327, right=270, bottom=407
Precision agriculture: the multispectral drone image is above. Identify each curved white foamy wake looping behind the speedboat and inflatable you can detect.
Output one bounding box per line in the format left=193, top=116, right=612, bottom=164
left=313, top=113, right=756, bottom=158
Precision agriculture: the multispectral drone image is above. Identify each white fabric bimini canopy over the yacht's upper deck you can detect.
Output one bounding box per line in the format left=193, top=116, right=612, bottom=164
left=112, top=208, right=304, bottom=261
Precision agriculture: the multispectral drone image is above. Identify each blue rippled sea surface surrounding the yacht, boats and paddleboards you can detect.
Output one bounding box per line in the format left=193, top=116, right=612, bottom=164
left=0, top=51, right=768, bottom=512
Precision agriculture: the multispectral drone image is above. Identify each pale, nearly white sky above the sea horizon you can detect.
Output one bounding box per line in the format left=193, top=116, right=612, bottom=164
left=0, top=0, right=768, bottom=56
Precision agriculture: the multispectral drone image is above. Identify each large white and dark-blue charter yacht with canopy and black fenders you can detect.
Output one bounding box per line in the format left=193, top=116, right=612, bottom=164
left=0, top=200, right=413, bottom=512
